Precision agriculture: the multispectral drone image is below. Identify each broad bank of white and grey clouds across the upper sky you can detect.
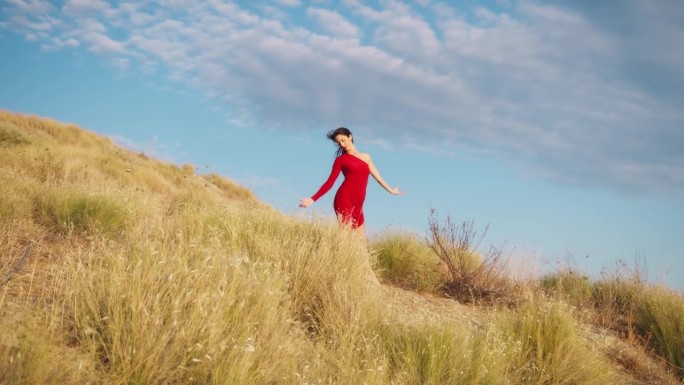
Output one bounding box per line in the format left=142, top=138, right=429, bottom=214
left=0, top=0, right=684, bottom=195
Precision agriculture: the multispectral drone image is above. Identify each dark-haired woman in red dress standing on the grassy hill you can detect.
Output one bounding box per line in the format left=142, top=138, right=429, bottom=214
left=299, top=127, right=401, bottom=234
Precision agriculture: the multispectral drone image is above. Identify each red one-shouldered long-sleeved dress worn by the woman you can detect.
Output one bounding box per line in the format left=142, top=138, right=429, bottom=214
left=311, top=153, right=370, bottom=229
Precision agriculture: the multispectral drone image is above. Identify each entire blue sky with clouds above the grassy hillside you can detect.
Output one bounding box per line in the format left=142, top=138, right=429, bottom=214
left=0, top=0, right=684, bottom=290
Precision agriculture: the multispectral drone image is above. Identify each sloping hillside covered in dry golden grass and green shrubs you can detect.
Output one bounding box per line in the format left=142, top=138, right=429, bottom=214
left=0, top=111, right=684, bottom=385
